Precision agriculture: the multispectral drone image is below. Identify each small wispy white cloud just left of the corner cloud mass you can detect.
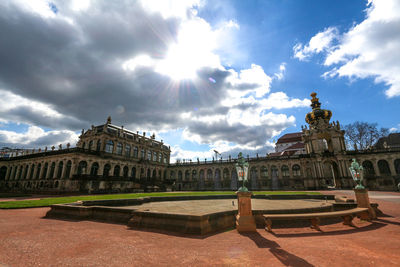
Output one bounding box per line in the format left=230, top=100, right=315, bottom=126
left=293, top=27, right=338, bottom=60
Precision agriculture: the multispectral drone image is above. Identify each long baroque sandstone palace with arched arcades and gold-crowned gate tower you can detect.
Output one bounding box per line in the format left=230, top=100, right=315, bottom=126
left=0, top=93, right=400, bottom=193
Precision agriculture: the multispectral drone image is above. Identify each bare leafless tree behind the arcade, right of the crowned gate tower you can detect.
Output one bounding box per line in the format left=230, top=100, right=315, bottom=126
left=344, top=121, right=389, bottom=150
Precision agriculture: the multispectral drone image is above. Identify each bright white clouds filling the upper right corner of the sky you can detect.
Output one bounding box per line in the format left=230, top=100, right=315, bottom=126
left=294, top=0, right=400, bottom=98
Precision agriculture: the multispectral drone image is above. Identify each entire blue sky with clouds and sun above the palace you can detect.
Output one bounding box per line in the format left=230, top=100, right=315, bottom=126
left=0, top=0, right=400, bottom=162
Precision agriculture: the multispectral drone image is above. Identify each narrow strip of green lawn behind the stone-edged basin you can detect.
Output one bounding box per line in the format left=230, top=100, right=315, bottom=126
left=0, top=191, right=321, bottom=209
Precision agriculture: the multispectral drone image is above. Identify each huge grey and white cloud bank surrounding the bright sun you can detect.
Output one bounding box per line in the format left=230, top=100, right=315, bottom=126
left=0, top=0, right=310, bottom=154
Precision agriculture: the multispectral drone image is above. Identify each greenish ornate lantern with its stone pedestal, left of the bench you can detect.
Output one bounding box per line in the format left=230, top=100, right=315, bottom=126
left=235, top=152, right=256, bottom=232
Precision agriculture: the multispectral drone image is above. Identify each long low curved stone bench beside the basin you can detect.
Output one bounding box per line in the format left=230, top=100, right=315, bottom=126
left=263, top=208, right=370, bottom=232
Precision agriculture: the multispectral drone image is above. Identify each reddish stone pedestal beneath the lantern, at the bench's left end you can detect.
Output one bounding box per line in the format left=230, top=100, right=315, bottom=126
left=236, top=192, right=256, bottom=232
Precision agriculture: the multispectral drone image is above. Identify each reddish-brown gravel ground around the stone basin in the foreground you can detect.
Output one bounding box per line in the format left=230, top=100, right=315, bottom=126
left=0, top=191, right=400, bottom=266
